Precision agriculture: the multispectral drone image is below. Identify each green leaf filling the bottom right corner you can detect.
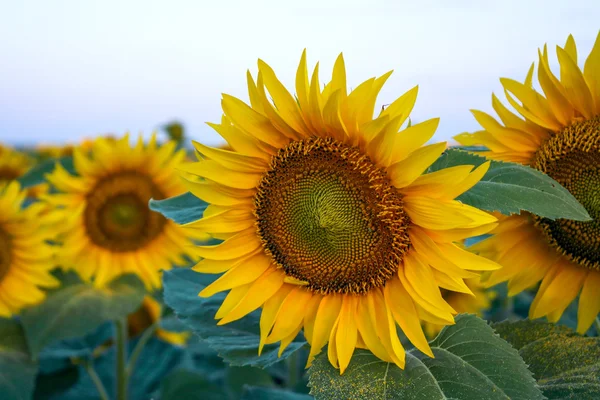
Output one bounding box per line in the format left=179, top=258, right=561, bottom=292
left=493, top=320, right=600, bottom=400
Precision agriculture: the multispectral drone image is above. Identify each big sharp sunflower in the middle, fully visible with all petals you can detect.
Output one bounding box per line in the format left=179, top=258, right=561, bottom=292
left=184, top=54, right=497, bottom=372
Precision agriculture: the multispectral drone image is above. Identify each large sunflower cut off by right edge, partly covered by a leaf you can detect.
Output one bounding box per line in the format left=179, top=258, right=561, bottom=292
left=456, top=35, right=600, bottom=332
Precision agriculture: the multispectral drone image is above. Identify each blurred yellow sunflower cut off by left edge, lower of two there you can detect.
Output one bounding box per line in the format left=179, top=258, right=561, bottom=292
left=0, top=181, right=59, bottom=317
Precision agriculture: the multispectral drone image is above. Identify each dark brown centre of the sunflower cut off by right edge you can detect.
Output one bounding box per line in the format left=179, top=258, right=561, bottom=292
left=533, top=116, right=600, bottom=270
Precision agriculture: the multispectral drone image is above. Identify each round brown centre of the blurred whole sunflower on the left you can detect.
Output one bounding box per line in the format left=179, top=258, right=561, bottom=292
left=85, top=172, right=166, bottom=252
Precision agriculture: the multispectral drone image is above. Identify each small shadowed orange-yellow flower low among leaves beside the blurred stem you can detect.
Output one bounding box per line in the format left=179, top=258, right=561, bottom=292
left=127, top=296, right=190, bottom=346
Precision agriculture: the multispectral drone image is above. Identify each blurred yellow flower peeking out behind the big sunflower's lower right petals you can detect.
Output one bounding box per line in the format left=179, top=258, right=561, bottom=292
left=423, top=278, right=496, bottom=338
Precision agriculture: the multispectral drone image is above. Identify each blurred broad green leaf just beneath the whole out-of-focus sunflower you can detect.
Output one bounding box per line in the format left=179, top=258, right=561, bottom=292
left=22, top=275, right=145, bottom=357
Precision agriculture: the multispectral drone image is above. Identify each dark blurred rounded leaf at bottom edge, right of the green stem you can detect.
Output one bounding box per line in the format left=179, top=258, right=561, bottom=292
left=160, top=370, right=229, bottom=400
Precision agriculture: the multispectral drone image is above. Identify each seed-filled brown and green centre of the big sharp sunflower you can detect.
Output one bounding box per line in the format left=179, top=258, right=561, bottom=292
left=254, top=138, right=410, bottom=294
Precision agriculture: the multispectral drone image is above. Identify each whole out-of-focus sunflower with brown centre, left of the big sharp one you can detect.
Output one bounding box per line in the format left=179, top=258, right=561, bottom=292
left=44, top=135, right=203, bottom=289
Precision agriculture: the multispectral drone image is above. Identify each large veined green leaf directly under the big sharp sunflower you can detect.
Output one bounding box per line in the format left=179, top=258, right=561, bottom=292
left=309, top=314, right=543, bottom=400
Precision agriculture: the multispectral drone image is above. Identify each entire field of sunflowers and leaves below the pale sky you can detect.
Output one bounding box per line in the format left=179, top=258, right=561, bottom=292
left=0, top=35, right=600, bottom=400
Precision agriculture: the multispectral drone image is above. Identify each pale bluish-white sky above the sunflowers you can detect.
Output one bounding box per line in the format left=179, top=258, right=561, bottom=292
left=0, top=0, right=600, bottom=145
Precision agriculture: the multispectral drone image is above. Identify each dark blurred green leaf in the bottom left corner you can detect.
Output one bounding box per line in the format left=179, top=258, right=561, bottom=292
left=0, top=319, right=37, bottom=400
